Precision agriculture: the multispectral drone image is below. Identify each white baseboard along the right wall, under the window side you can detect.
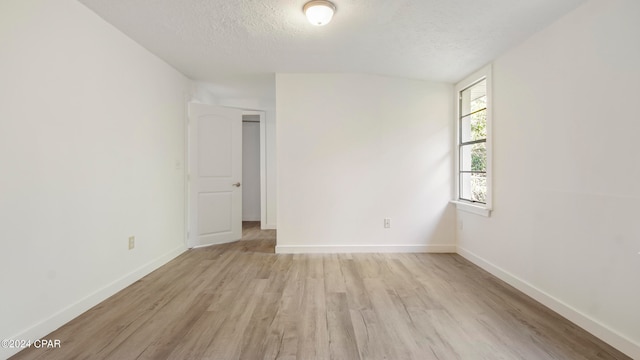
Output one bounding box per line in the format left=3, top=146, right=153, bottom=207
left=457, top=246, right=640, bottom=359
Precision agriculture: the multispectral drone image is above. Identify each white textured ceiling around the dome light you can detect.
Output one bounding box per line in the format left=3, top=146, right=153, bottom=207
left=80, top=0, right=585, bottom=97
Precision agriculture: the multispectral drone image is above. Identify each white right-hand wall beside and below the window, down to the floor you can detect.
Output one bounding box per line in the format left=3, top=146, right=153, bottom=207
left=458, top=0, right=640, bottom=359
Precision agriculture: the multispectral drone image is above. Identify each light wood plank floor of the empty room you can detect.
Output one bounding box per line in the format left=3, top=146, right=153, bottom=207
left=12, top=223, right=629, bottom=360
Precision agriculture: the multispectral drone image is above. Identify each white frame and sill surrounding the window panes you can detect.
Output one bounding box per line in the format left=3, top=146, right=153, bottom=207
left=452, top=65, right=493, bottom=216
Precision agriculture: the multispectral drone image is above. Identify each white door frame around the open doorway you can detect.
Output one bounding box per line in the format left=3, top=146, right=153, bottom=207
left=183, top=104, right=268, bottom=248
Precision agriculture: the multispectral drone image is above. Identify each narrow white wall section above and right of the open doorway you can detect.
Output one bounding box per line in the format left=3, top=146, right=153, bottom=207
left=192, top=81, right=277, bottom=229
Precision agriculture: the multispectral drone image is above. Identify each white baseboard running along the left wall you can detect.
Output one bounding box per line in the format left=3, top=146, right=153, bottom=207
left=0, top=246, right=187, bottom=359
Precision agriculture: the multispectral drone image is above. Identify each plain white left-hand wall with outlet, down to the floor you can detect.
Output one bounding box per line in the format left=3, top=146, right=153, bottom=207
left=0, top=0, right=189, bottom=358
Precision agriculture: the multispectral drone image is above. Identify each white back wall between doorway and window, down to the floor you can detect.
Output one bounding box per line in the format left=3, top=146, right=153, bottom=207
left=276, top=74, right=455, bottom=252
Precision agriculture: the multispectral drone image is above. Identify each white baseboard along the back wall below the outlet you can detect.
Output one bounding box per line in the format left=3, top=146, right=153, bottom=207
left=276, top=244, right=456, bottom=254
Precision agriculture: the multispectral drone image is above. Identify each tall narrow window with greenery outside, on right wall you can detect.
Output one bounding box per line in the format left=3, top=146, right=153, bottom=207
left=456, top=67, right=491, bottom=215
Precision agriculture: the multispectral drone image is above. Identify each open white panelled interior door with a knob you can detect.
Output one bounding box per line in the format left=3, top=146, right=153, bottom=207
left=189, top=103, right=242, bottom=247
